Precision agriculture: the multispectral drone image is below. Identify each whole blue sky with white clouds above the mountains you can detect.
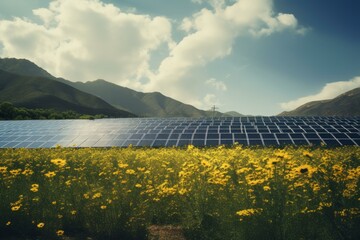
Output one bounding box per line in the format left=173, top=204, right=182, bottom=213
left=0, top=0, right=360, bottom=115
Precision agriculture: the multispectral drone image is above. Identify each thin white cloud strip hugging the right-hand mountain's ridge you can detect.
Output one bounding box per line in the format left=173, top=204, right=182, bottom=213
left=280, top=76, right=360, bottom=111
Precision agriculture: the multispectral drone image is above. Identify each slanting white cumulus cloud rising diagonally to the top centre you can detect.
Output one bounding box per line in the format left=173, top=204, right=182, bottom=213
left=146, top=0, right=303, bottom=106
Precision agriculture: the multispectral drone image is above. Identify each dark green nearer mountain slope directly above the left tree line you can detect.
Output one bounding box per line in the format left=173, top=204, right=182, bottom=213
left=0, top=70, right=134, bottom=117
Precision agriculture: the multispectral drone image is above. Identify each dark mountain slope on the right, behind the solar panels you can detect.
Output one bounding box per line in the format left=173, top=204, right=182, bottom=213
left=279, top=88, right=360, bottom=116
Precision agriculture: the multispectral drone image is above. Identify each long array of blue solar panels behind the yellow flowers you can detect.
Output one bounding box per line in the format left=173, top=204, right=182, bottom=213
left=0, top=117, right=360, bottom=148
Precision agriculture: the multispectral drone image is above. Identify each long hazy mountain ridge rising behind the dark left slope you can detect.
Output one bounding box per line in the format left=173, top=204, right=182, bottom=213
left=0, top=58, right=242, bottom=117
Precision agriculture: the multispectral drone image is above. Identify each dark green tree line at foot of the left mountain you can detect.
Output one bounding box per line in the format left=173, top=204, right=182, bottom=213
left=0, top=102, right=107, bottom=120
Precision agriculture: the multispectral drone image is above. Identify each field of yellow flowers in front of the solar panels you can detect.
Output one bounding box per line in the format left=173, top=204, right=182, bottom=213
left=0, top=146, right=360, bottom=240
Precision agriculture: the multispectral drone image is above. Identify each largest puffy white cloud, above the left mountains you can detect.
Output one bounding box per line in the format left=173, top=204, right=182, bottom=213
left=0, top=0, right=172, bottom=85
